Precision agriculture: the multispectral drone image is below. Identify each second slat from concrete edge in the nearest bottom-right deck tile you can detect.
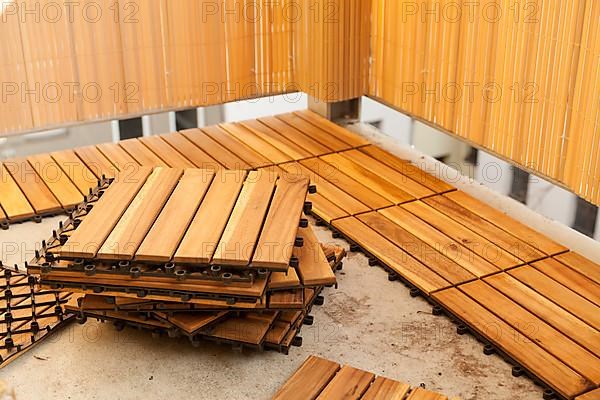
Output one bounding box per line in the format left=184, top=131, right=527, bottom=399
left=460, top=281, right=600, bottom=385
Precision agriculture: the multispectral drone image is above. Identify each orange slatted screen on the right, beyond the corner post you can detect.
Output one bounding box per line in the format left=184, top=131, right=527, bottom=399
left=368, top=0, right=600, bottom=204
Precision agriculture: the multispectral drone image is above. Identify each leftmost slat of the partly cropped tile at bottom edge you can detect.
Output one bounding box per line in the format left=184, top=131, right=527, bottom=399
left=273, top=356, right=340, bottom=400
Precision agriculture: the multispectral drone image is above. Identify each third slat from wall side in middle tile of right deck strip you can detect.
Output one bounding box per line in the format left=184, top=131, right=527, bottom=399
left=400, top=201, right=524, bottom=269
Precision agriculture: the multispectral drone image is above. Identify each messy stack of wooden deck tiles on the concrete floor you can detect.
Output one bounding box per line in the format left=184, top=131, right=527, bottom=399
left=28, top=167, right=343, bottom=352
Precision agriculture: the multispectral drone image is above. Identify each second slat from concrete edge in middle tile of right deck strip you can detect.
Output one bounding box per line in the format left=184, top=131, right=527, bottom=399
left=357, top=212, right=476, bottom=285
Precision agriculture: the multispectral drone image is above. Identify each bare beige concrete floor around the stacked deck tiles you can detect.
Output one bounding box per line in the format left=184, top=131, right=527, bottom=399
left=0, top=217, right=541, bottom=400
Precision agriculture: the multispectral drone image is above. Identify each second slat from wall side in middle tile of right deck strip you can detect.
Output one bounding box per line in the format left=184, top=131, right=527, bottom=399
left=423, top=196, right=546, bottom=261
